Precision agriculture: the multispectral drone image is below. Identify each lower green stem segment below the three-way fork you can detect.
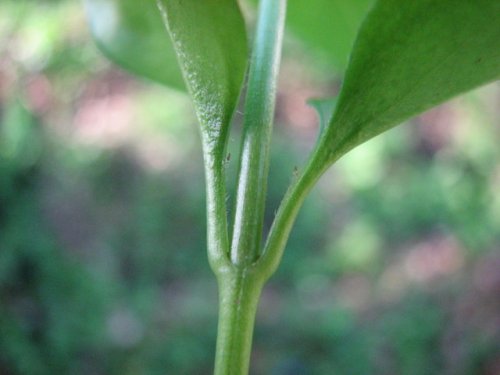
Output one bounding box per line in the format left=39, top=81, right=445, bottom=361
left=214, top=269, right=263, bottom=375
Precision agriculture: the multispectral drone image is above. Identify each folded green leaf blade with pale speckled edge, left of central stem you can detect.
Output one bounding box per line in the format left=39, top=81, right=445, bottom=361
left=158, top=0, right=248, bottom=147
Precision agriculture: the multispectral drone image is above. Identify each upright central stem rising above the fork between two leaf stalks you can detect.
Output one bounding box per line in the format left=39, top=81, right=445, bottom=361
left=231, top=0, right=286, bottom=266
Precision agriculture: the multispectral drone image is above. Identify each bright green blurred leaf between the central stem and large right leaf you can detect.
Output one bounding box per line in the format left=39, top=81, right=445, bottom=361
left=287, top=0, right=373, bottom=72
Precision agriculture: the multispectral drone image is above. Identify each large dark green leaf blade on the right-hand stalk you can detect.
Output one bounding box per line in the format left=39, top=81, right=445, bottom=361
left=319, top=0, right=500, bottom=163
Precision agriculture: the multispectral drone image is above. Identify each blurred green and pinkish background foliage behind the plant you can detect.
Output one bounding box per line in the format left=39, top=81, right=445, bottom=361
left=0, top=0, right=500, bottom=375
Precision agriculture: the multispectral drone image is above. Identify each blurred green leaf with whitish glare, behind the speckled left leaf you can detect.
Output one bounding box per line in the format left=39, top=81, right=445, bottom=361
left=84, top=0, right=185, bottom=89
